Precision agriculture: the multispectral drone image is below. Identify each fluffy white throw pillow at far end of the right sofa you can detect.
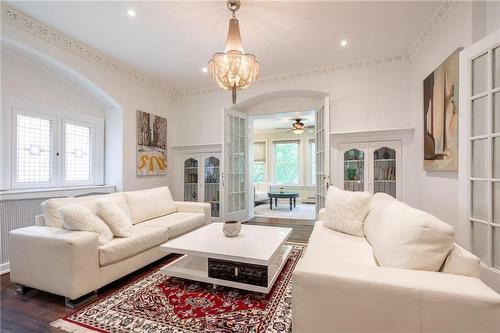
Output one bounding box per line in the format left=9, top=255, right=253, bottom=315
left=324, top=186, right=370, bottom=237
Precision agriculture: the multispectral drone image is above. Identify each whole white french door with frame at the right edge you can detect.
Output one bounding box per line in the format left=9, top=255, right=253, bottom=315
left=459, top=30, right=500, bottom=291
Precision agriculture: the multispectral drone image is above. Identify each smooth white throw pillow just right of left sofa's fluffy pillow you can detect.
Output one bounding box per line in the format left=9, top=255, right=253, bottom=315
left=97, top=199, right=132, bottom=237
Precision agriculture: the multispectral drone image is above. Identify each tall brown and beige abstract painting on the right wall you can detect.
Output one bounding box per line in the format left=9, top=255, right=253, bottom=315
left=424, top=49, right=461, bottom=171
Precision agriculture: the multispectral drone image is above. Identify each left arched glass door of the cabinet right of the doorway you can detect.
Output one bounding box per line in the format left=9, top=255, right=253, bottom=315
left=344, top=149, right=365, bottom=191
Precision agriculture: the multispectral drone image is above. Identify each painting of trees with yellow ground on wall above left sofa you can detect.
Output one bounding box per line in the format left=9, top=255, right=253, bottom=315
left=136, top=110, right=167, bottom=176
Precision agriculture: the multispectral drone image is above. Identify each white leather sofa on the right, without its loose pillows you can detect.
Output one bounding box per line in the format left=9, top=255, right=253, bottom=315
left=292, top=193, right=500, bottom=333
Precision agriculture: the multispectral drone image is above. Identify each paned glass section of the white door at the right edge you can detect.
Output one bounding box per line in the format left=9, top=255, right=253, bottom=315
left=468, top=46, right=500, bottom=269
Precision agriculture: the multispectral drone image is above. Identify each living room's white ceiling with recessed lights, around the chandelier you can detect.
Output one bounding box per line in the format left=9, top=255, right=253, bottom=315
left=9, top=0, right=440, bottom=92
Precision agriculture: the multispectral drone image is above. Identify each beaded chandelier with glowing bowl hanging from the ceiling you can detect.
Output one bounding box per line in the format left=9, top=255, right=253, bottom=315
left=208, top=0, right=259, bottom=104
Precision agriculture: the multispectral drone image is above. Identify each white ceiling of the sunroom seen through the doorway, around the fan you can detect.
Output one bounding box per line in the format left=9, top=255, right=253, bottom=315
left=251, top=111, right=315, bottom=133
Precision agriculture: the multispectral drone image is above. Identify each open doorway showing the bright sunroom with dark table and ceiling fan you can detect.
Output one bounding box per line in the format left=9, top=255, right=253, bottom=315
left=249, top=110, right=317, bottom=220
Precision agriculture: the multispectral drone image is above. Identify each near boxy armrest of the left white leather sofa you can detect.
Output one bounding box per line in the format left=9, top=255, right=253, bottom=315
left=9, top=226, right=99, bottom=299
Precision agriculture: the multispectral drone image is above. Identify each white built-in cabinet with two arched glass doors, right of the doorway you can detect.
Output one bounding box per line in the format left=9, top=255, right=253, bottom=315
left=338, top=141, right=402, bottom=199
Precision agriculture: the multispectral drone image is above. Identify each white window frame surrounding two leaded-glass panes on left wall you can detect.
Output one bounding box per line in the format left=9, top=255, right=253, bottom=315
left=9, top=99, right=104, bottom=190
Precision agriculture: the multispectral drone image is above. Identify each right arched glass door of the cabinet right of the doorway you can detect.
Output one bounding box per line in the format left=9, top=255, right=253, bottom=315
left=373, top=147, right=396, bottom=197
